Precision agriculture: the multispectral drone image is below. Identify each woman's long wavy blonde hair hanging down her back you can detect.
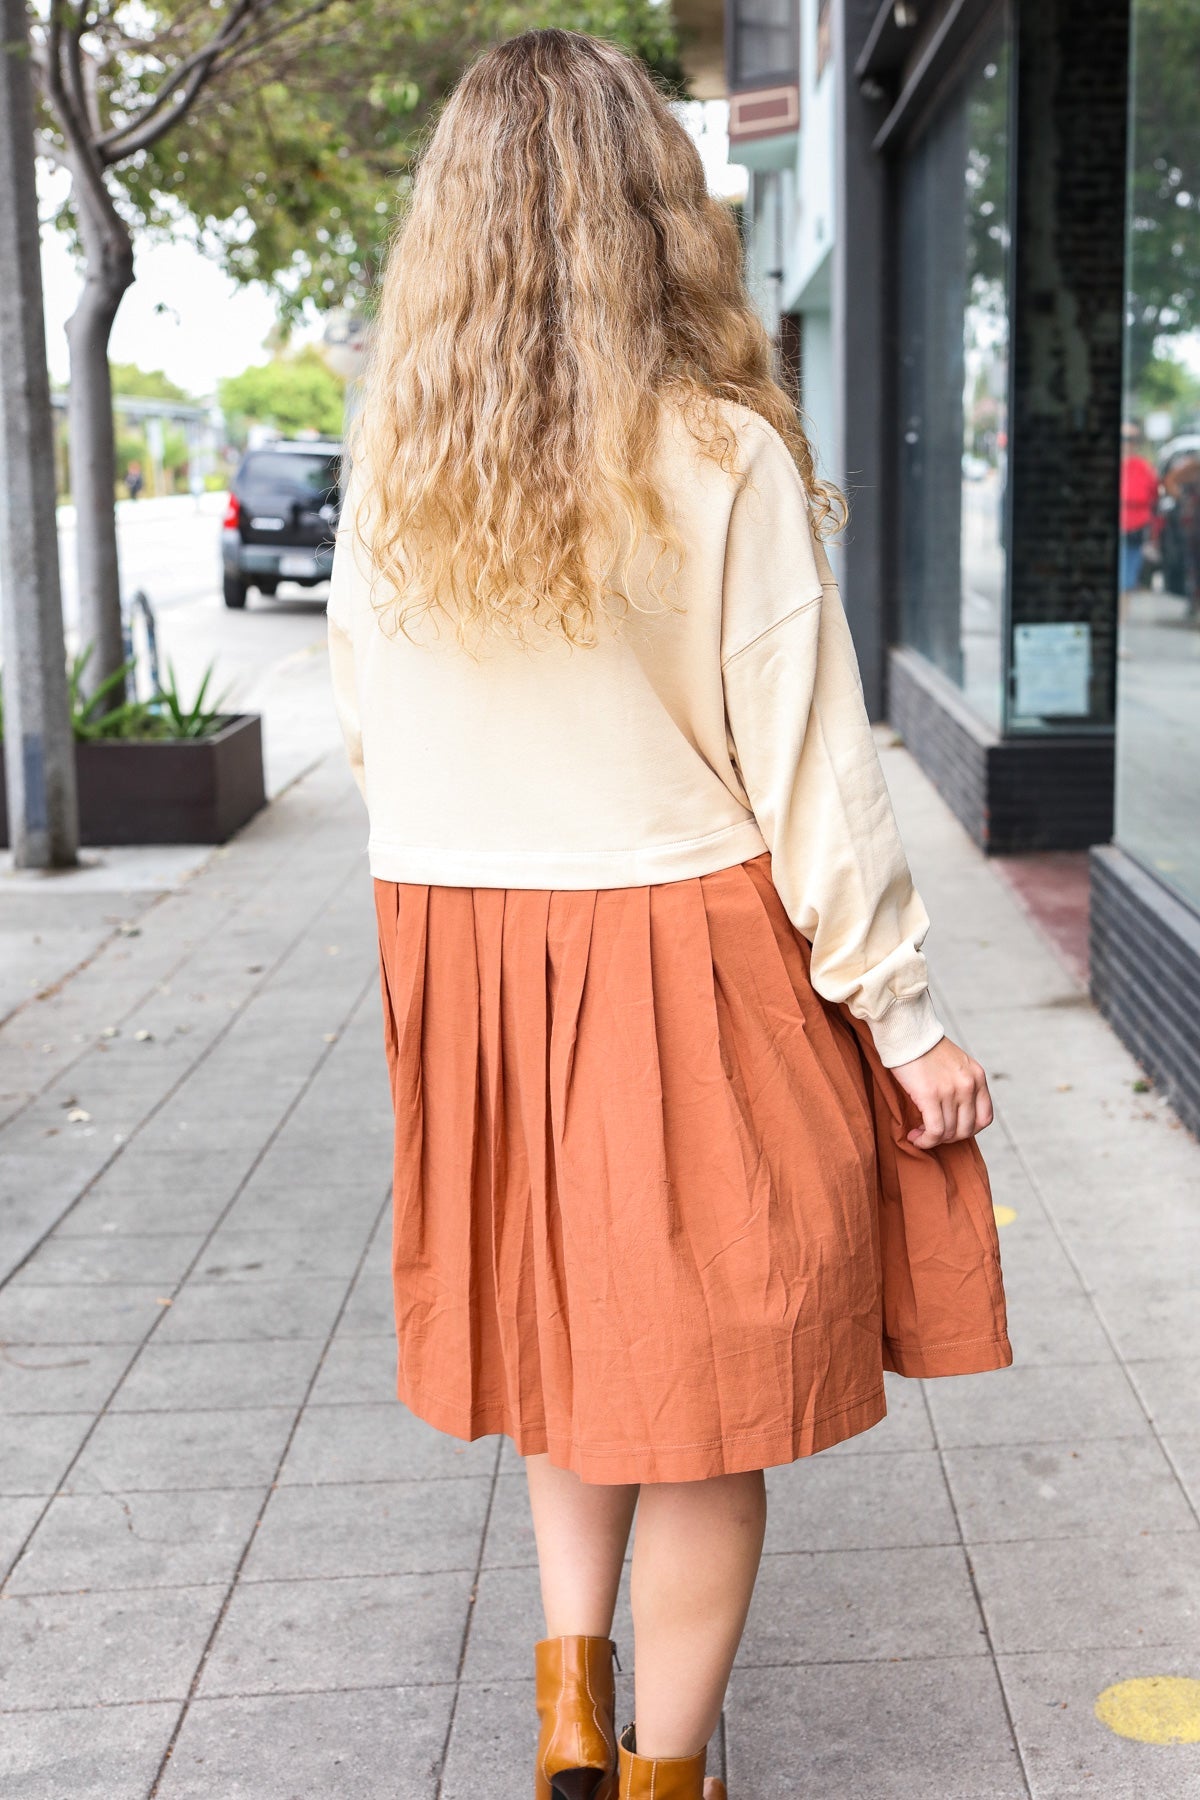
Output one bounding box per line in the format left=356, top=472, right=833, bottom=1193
left=351, top=31, right=840, bottom=644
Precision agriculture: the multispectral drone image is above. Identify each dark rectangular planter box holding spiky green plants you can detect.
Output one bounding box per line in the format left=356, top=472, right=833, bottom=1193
left=0, top=713, right=266, bottom=844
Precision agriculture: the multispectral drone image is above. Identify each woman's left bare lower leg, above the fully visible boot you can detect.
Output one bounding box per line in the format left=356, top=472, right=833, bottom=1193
left=525, top=1456, right=637, bottom=1638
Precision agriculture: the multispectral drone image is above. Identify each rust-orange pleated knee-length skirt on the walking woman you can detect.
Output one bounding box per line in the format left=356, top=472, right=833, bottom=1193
left=376, top=855, right=1013, bottom=1481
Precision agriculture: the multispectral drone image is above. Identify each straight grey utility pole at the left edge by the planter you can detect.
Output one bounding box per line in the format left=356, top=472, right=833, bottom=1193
left=0, top=0, right=79, bottom=869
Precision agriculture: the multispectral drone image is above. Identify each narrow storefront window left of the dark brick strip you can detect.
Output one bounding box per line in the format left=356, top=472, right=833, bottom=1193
left=900, top=14, right=1009, bottom=727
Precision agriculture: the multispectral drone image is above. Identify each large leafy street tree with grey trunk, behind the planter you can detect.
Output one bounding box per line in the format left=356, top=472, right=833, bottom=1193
left=32, top=0, right=678, bottom=684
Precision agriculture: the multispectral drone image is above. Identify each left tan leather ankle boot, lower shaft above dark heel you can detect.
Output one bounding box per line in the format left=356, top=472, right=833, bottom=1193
left=533, top=1638, right=617, bottom=1800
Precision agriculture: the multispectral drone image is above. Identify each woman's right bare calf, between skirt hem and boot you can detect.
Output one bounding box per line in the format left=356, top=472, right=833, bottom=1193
left=633, top=1471, right=766, bottom=1757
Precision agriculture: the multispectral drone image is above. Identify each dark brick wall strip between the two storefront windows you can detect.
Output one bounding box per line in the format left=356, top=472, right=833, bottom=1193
left=1011, top=0, right=1130, bottom=724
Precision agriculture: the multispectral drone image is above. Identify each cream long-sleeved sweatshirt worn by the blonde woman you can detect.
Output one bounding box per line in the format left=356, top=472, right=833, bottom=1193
left=329, top=405, right=943, bottom=1067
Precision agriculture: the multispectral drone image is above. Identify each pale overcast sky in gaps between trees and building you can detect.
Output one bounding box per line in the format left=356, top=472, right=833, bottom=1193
left=41, top=101, right=743, bottom=396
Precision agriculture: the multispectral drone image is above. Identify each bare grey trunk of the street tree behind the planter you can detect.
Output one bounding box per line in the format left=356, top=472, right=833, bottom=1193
left=67, top=197, right=133, bottom=706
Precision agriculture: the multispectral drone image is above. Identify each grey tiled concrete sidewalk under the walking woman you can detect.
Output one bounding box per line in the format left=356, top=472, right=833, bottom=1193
left=0, top=749, right=1200, bottom=1800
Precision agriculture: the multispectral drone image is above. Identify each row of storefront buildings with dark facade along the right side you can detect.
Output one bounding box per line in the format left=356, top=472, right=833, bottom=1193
left=676, top=0, right=1200, bottom=1127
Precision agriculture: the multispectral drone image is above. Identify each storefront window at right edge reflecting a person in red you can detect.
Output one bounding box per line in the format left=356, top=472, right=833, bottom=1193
left=1115, top=0, right=1200, bottom=905
